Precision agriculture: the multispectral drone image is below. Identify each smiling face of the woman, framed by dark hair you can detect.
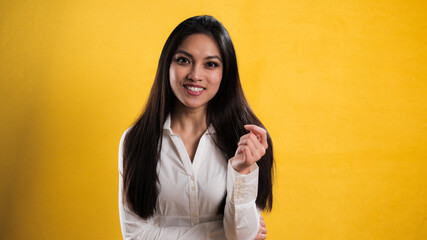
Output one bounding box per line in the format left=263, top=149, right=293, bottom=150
left=169, top=34, right=223, bottom=109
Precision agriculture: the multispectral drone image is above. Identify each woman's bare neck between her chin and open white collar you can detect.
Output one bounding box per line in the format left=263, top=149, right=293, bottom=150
left=171, top=103, right=207, bottom=135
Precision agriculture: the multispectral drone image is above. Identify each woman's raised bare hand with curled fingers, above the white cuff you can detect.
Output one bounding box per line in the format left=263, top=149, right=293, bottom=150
left=231, top=124, right=268, bottom=174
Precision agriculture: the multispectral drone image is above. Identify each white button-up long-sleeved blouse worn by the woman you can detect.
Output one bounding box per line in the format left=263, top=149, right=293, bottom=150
left=119, top=115, right=260, bottom=240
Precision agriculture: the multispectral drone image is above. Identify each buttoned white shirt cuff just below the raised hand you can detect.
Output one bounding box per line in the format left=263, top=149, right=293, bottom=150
left=227, top=161, right=259, bottom=204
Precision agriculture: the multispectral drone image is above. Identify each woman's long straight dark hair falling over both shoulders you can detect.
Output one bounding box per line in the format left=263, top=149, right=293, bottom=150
left=123, top=15, right=274, bottom=219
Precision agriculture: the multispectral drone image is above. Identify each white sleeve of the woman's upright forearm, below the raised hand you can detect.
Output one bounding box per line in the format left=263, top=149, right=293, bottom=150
left=224, top=161, right=261, bottom=240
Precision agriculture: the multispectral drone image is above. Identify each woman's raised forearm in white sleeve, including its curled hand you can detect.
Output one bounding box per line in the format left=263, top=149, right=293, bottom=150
left=224, top=125, right=268, bottom=240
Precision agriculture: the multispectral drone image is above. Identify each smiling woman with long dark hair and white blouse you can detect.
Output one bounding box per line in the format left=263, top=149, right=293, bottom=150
left=119, top=16, right=273, bottom=240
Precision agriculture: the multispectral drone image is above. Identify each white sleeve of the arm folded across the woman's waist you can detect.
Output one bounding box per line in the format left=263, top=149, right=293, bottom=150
left=118, top=130, right=224, bottom=240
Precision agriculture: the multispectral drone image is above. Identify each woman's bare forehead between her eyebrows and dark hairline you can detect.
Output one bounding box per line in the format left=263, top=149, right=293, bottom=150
left=176, top=34, right=220, bottom=56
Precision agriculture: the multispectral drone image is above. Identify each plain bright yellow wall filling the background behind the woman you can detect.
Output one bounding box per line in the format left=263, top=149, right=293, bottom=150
left=0, top=0, right=427, bottom=240
